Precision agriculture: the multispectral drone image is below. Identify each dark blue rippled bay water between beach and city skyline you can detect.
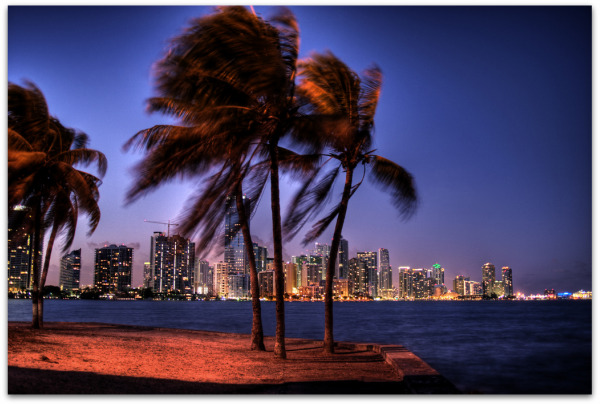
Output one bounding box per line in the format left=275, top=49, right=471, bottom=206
left=8, top=300, right=592, bottom=394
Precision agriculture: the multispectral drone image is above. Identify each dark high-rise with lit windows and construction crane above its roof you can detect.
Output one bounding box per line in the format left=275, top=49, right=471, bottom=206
left=150, top=232, right=195, bottom=293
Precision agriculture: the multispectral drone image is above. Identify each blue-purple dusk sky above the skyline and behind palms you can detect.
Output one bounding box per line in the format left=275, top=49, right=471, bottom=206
left=8, top=6, right=592, bottom=293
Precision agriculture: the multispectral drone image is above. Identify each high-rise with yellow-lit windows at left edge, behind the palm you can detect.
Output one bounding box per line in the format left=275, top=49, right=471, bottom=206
left=7, top=206, right=44, bottom=292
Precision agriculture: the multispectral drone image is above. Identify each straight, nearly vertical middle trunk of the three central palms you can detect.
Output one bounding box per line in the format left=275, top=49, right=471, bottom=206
left=269, top=141, right=286, bottom=359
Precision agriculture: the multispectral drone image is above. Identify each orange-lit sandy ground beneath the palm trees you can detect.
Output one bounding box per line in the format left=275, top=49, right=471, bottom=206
left=8, top=322, right=426, bottom=394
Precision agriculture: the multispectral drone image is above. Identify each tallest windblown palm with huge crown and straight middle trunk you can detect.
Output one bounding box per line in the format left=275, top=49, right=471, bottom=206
left=124, top=7, right=310, bottom=358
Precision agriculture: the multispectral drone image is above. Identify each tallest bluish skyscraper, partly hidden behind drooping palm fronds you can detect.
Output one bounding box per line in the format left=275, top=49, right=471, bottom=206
left=224, top=195, right=249, bottom=274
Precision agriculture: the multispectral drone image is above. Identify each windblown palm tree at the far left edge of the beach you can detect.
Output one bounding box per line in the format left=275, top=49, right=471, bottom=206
left=8, top=82, right=106, bottom=328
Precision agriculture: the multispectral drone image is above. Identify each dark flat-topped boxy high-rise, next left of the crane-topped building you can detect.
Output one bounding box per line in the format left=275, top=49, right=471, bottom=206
left=94, top=244, right=133, bottom=293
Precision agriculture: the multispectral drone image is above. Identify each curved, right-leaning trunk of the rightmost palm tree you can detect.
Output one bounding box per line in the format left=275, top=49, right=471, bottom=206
left=323, top=168, right=353, bottom=354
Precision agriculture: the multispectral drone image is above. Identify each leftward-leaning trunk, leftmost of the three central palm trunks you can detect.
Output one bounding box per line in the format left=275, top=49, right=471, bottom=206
left=235, top=181, right=265, bottom=351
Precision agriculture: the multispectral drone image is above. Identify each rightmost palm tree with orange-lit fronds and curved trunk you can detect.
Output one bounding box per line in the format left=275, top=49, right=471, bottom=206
left=285, top=52, right=417, bottom=353
